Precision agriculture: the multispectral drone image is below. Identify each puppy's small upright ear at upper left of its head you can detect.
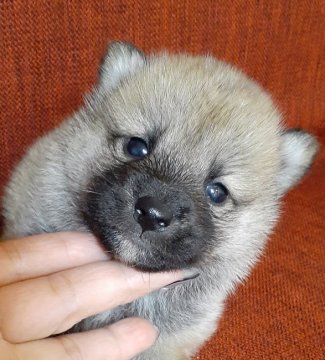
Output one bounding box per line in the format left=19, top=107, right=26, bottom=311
left=99, top=42, right=146, bottom=89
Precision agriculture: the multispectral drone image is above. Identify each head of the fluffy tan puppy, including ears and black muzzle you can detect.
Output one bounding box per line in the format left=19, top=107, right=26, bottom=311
left=80, top=43, right=317, bottom=276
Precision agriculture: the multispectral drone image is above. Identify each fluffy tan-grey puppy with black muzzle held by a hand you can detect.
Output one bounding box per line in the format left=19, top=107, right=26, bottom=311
left=3, top=43, right=318, bottom=360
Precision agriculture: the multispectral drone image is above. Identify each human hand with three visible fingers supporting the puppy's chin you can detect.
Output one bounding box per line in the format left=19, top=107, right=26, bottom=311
left=0, top=233, right=186, bottom=360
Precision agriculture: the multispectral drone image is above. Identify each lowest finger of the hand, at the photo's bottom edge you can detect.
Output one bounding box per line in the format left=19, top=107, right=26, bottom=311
left=10, top=318, right=157, bottom=360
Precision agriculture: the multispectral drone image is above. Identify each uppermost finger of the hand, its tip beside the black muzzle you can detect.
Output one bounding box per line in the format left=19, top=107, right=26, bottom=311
left=0, top=232, right=108, bottom=286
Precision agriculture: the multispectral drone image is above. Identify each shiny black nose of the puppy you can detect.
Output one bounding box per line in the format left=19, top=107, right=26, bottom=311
left=134, top=196, right=173, bottom=232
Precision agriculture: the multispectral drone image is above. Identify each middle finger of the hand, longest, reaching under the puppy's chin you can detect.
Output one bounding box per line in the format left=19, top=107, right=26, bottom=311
left=0, top=261, right=184, bottom=343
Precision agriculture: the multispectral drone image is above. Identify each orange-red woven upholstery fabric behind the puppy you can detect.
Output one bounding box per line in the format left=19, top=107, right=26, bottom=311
left=0, top=0, right=325, bottom=360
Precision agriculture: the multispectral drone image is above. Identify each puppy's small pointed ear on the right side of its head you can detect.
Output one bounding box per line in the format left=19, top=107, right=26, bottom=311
left=278, top=129, right=319, bottom=195
